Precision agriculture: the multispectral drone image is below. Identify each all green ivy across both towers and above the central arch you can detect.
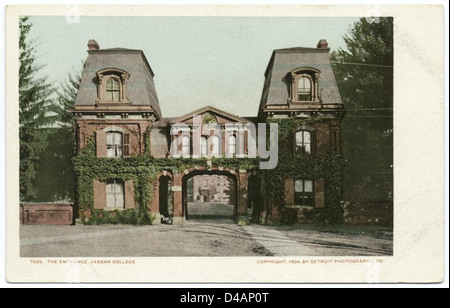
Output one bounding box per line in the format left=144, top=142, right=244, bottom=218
left=73, top=117, right=344, bottom=224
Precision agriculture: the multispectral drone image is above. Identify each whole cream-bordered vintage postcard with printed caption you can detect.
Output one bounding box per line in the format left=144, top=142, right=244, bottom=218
left=6, top=5, right=444, bottom=283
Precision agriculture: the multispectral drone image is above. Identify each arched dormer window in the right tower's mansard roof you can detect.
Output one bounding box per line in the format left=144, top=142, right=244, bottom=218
left=290, top=68, right=320, bottom=103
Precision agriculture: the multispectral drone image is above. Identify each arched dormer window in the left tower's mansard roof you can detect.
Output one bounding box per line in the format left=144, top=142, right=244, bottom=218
left=96, top=68, right=130, bottom=104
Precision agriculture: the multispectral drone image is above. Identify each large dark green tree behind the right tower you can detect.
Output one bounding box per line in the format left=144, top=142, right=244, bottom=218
left=332, top=18, right=393, bottom=201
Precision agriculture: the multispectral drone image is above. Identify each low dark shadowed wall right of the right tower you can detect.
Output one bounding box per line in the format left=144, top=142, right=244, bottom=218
left=342, top=201, right=394, bottom=226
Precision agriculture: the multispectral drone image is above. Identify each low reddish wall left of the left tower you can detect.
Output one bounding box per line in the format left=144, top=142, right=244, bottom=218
left=20, top=203, right=73, bottom=225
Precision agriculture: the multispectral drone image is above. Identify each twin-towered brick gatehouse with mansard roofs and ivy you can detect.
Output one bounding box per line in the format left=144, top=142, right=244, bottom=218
left=71, top=40, right=344, bottom=224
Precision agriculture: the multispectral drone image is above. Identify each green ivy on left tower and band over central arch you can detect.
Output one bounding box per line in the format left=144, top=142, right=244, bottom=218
left=72, top=134, right=258, bottom=224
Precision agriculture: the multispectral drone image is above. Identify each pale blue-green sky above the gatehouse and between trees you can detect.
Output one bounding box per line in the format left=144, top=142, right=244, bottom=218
left=29, top=16, right=358, bottom=117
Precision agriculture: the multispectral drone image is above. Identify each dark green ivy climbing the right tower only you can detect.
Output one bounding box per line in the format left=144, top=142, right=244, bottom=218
left=260, top=117, right=345, bottom=224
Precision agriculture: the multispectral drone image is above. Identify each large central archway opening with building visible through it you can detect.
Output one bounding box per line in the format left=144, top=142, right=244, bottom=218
left=182, top=170, right=238, bottom=220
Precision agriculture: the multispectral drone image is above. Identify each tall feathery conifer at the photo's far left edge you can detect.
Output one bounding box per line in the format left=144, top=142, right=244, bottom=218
left=19, top=17, right=56, bottom=201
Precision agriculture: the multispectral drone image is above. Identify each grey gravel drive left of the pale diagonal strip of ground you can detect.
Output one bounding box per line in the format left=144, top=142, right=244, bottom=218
left=20, top=220, right=268, bottom=257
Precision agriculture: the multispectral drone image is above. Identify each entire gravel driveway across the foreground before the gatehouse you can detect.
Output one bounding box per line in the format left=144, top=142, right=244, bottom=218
left=20, top=219, right=393, bottom=257
